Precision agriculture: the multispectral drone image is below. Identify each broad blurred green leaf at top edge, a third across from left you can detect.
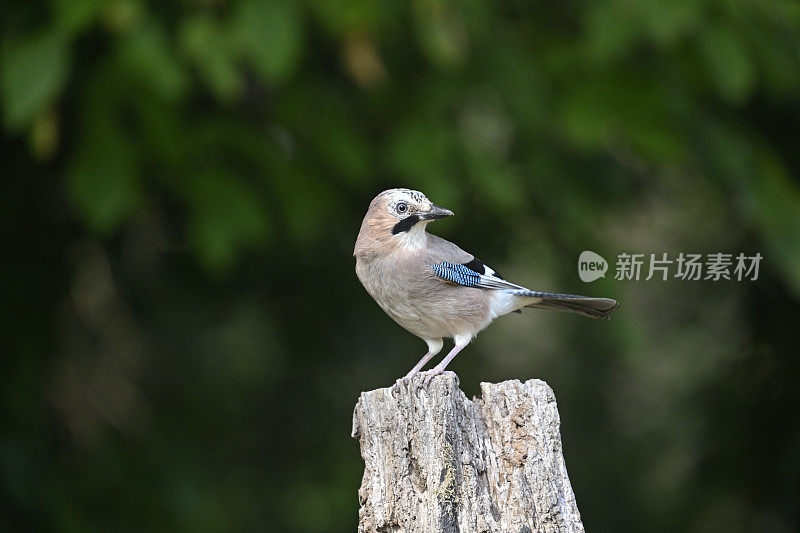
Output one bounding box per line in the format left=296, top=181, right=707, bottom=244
left=231, top=0, right=303, bottom=82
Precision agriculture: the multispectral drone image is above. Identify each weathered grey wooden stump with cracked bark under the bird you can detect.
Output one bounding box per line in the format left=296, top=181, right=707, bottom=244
left=353, top=375, right=583, bottom=533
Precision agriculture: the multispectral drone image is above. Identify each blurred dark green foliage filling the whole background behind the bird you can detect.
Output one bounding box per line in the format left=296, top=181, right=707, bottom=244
left=0, top=0, right=800, bottom=531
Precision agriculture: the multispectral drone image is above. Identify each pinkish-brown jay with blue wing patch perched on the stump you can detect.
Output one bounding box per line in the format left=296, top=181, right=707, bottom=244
left=353, top=188, right=619, bottom=386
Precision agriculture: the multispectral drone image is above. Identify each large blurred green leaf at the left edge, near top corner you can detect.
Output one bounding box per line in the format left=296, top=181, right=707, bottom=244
left=0, top=32, right=70, bottom=131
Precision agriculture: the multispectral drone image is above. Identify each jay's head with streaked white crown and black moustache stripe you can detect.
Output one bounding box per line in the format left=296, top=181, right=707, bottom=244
left=359, top=189, right=453, bottom=254
